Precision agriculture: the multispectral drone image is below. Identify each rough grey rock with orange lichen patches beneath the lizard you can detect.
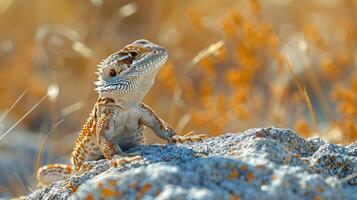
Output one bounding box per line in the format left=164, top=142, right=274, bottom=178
left=26, top=128, right=357, bottom=200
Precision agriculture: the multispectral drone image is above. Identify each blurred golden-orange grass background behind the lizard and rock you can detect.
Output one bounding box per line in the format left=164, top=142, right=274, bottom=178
left=0, top=0, right=357, bottom=197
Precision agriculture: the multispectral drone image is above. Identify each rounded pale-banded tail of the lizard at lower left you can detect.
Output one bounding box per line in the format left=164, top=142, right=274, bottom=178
left=37, top=164, right=74, bottom=186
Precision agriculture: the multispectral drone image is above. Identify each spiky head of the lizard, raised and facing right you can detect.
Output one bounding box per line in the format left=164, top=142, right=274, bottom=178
left=95, top=39, right=168, bottom=107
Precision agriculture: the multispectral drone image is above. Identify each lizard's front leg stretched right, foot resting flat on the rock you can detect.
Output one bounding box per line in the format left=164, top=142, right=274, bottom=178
left=140, top=103, right=207, bottom=143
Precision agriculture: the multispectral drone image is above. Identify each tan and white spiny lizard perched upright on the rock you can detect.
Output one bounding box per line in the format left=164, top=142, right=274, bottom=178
left=37, top=39, right=207, bottom=186
